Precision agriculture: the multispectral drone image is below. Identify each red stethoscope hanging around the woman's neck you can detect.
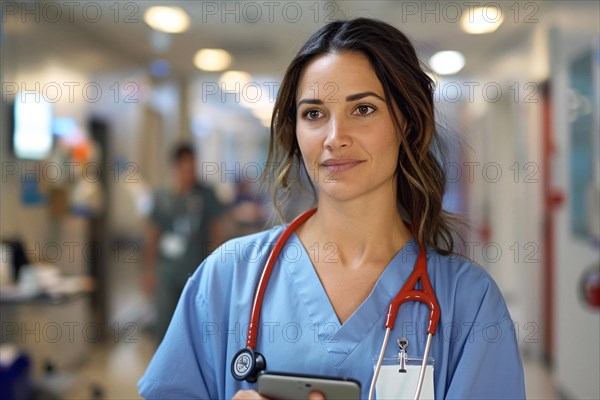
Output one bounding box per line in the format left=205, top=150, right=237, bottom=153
left=231, top=208, right=440, bottom=399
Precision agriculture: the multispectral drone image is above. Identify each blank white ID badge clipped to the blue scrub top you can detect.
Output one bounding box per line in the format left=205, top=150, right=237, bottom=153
left=375, top=357, right=434, bottom=400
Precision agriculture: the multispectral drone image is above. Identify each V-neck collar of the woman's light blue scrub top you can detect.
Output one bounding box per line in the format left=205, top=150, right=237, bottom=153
left=284, top=233, right=419, bottom=366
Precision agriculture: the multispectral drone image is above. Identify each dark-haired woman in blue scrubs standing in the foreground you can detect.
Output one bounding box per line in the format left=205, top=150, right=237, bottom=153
left=139, top=19, right=525, bottom=399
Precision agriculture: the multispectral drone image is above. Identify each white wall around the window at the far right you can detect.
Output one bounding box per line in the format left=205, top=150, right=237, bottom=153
left=551, top=25, right=600, bottom=399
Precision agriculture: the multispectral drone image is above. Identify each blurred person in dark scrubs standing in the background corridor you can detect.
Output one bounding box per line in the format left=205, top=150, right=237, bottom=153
left=142, top=144, right=224, bottom=343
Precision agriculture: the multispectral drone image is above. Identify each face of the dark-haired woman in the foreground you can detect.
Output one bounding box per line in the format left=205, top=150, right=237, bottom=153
left=296, top=52, right=400, bottom=205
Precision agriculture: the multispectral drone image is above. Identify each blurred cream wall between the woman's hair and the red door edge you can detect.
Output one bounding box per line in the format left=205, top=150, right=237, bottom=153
left=463, top=25, right=548, bottom=358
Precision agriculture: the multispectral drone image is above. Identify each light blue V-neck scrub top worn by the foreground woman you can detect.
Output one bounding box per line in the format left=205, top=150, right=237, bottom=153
left=138, top=226, right=525, bottom=399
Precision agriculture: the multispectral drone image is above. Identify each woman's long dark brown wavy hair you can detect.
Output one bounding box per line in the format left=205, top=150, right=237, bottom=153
left=263, top=18, right=460, bottom=254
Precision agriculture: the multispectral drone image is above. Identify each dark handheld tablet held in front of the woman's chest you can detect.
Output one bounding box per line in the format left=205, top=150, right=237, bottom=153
left=258, top=371, right=360, bottom=400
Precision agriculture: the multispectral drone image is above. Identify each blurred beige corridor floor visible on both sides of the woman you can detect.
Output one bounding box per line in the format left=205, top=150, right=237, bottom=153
left=35, top=334, right=560, bottom=400
